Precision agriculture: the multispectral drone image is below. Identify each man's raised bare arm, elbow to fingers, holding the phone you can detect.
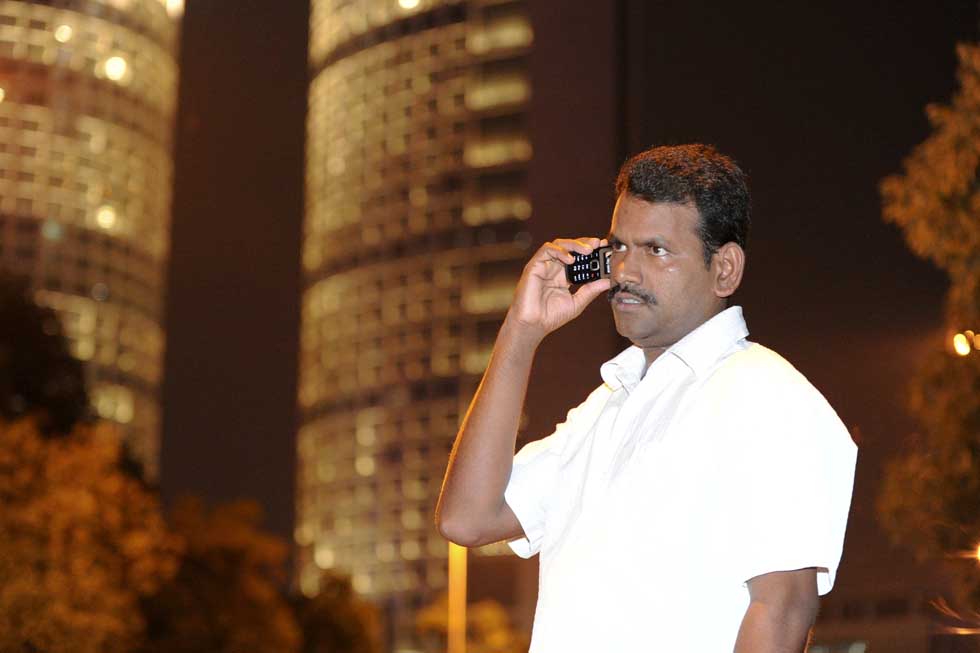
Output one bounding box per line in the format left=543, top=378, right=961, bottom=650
left=436, top=238, right=610, bottom=546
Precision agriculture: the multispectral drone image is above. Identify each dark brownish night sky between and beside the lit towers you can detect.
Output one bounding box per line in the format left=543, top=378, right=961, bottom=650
left=162, top=0, right=978, bottom=582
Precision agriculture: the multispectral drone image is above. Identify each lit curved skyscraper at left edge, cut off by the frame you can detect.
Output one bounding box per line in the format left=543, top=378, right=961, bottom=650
left=0, top=0, right=183, bottom=478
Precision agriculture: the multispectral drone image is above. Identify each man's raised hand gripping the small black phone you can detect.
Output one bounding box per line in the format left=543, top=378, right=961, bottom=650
left=507, top=238, right=612, bottom=340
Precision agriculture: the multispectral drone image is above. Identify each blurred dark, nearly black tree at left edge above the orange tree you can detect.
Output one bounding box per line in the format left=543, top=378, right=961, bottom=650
left=0, top=273, right=88, bottom=435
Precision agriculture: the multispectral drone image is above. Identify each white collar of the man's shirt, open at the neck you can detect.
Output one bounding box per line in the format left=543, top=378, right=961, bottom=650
left=599, top=306, right=749, bottom=390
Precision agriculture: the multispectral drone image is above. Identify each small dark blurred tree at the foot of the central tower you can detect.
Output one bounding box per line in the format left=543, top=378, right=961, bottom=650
left=295, top=573, right=381, bottom=653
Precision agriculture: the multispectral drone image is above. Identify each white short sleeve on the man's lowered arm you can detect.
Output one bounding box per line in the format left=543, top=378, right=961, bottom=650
left=731, top=382, right=857, bottom=595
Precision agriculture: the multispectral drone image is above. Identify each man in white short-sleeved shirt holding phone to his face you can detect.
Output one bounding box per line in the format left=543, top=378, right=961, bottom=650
left=436, top=145, right=856, bottom=653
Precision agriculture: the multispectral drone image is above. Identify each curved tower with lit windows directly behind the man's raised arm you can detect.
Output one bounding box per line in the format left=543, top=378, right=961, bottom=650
left=296, top=0, right=533, bottom=644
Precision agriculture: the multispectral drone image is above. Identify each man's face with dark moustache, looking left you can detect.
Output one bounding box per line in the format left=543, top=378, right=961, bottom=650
left=609, top=193, right=724, bottom=360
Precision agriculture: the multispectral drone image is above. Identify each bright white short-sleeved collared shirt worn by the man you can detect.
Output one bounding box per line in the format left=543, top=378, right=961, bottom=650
left=505, top=307, right=857, bottom=653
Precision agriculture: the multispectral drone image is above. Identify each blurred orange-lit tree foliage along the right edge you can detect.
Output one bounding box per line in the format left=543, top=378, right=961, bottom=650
left=878, top=44, right=980, bottom=610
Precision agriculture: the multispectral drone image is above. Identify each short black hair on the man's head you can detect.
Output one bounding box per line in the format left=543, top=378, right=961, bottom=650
left=616, top=143, right=751, bottom=265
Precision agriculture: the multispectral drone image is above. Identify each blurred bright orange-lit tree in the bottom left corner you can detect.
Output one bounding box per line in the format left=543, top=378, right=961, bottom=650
left=0, top=419, right=177, bottom=653
